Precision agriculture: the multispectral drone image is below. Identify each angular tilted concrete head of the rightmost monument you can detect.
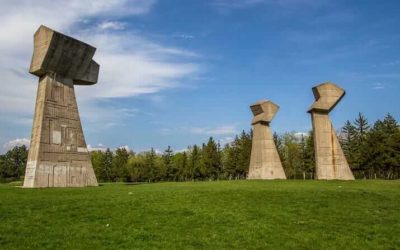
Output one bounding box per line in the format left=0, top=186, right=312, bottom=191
left=308, top=82, right=346, bottom=112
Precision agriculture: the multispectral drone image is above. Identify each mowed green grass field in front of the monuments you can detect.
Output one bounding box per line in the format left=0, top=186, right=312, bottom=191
left=0, top=181, right=400, bottom=249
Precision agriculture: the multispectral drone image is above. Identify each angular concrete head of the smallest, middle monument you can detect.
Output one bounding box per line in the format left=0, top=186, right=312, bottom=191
left=250, top=100, right=279, bottom=124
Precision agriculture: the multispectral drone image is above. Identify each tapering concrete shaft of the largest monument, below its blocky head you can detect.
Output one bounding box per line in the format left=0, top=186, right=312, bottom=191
left=24, top=74, right=98, bottom=188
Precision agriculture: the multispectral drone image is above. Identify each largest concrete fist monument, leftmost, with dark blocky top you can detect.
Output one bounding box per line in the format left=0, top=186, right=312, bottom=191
left=24, top=26, right=99, bottom=188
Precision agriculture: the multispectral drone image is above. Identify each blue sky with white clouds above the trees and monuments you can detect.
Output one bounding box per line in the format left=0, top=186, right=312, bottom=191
left=0, top=0, right=400, bottom=152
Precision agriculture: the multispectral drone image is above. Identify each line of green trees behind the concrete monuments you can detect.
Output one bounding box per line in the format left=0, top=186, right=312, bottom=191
left=0, top=113, right=400, bottom=182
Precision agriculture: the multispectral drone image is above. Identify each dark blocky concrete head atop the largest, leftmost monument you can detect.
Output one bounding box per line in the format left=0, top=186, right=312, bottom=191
left=29, top=25, right=100, bottom=85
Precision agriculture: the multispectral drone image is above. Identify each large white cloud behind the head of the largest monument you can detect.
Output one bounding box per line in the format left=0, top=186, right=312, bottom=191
left=0, top=0, right=200, bottom=132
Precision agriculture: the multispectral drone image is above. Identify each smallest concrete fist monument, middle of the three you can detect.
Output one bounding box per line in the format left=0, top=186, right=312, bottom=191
left=248, top=100, right=286, bottom=179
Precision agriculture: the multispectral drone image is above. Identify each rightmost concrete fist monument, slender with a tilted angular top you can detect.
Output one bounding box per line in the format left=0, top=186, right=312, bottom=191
left=308, top=82, right=354, bottom=180
